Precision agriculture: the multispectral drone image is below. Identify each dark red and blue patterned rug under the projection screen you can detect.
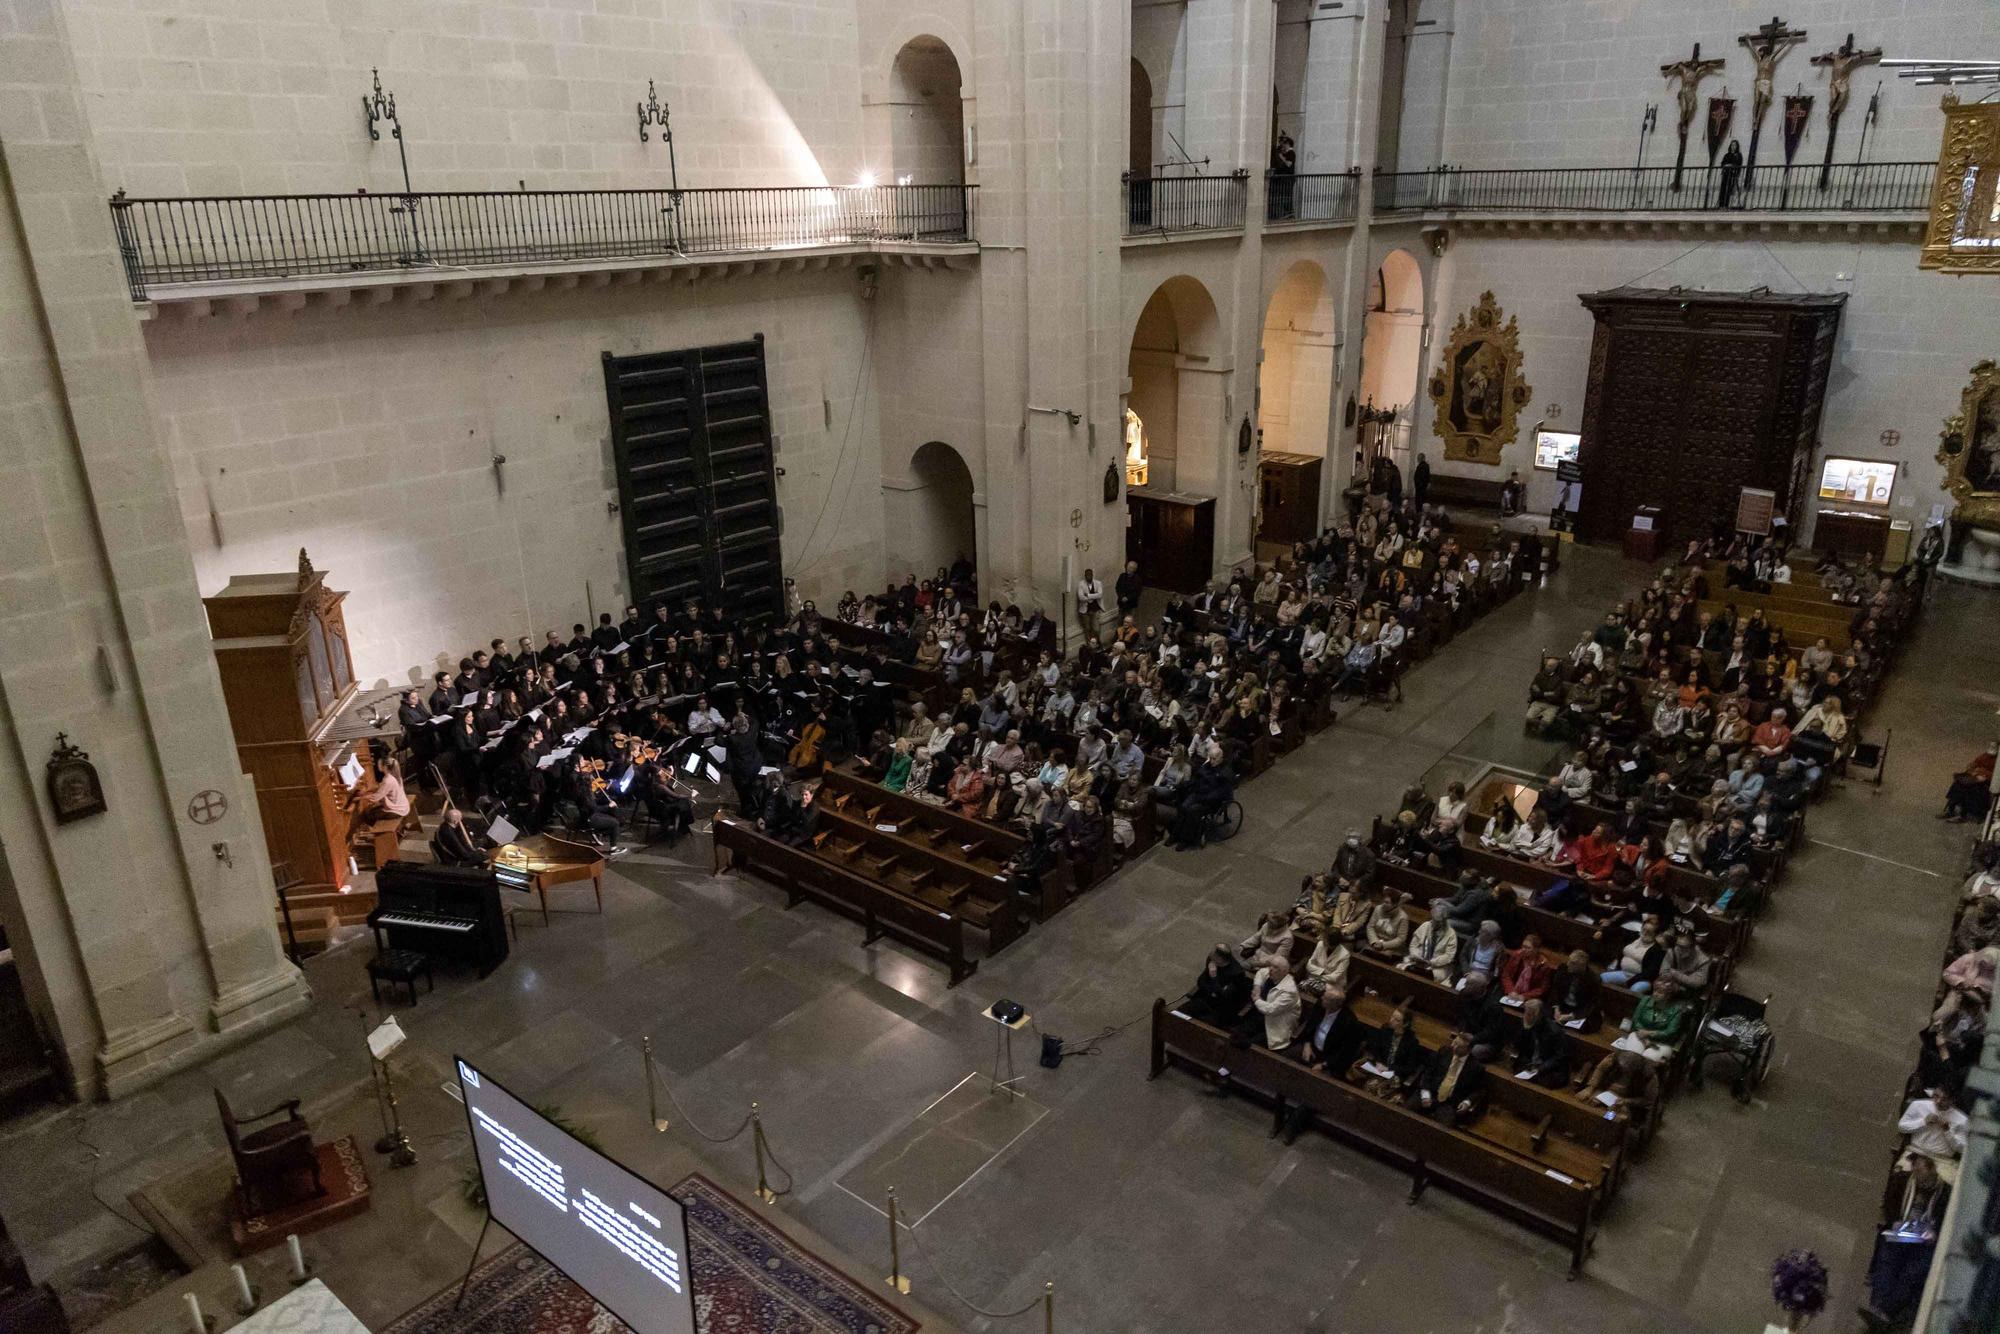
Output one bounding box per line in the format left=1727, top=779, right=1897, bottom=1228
left=384, top=1174, right=920, bottom=1334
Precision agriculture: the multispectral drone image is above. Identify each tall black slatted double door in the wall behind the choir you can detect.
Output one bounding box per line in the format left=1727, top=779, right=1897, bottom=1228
left=604, top=334, right=784, bottom=624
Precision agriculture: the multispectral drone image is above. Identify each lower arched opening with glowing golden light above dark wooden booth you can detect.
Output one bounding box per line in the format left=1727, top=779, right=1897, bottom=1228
left=1128, top=276, right=1234, bottom=592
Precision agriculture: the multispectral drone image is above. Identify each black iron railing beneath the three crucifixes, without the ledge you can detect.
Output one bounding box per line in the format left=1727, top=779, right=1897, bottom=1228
left=1374, top=162, right=1938, bottom=214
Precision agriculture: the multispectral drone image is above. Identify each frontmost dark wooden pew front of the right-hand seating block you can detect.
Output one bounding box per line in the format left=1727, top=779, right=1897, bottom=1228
left=1148, top=1000, right=1610, bottom=1278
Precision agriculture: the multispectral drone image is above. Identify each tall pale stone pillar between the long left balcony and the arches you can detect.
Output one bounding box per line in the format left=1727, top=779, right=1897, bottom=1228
left=976, top=0, right=1130, bottom=640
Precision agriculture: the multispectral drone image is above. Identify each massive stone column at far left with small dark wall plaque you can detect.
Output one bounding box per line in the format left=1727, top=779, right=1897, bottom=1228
left=0, top=0, right=308, bottom=1096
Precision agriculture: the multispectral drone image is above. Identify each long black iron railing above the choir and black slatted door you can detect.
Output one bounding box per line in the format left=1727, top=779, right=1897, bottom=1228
left=110, top=186, right=976, bottom=300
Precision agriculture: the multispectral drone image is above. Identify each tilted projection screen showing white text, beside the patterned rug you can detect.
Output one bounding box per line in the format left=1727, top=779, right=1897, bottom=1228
left=456, top=1060, right=694, bottom=1334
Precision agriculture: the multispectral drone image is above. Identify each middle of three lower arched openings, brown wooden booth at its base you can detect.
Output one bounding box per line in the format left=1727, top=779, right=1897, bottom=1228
left=1256, top=260, right=1334, bottom=544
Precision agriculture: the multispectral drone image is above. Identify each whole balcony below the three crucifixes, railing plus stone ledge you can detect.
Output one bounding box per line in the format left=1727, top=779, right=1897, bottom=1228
left=1374, top=162, right=1938, bottom=230
